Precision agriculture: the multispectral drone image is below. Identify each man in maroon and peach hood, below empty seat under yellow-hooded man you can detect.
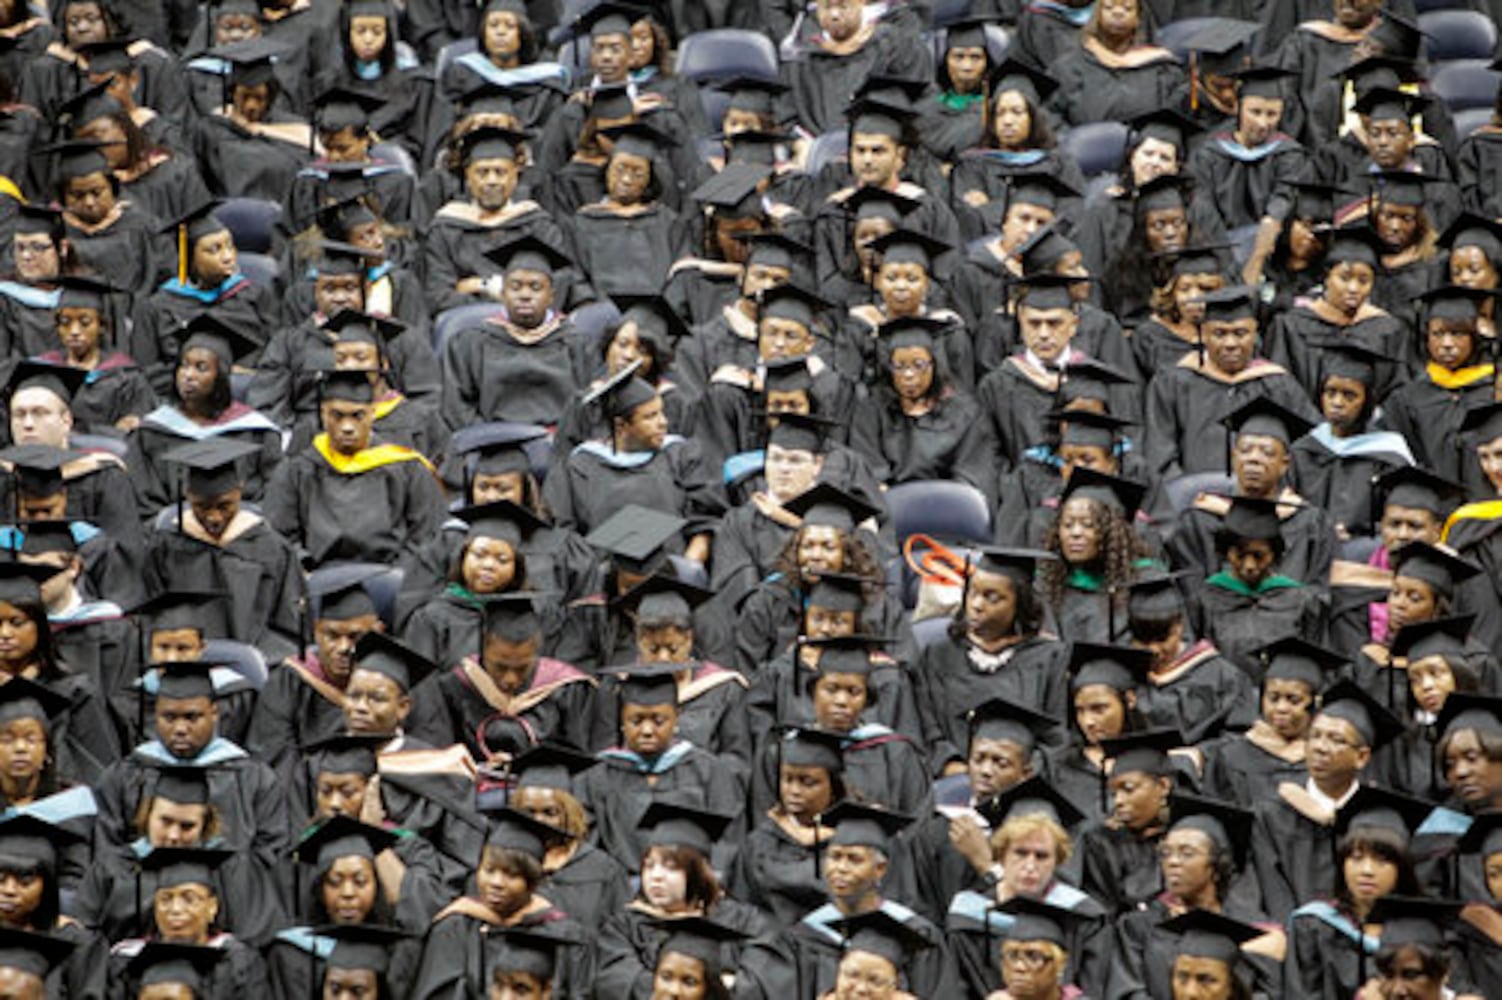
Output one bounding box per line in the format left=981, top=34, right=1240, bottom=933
left=245, top=567, right=386, bottom=773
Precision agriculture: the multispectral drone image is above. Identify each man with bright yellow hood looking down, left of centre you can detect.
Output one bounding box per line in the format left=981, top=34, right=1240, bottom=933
left=264, top=371, right=443, bottom=566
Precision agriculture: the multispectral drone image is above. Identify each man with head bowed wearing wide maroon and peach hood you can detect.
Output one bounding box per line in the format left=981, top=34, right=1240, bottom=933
left=410, top=590, right=596, bottom=761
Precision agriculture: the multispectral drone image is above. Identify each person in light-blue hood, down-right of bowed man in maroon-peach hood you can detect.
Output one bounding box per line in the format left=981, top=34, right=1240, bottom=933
left=578, top=664, right=745, bottom=874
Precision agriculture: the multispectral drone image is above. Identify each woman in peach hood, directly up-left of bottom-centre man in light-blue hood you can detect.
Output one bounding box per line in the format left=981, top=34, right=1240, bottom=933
left=728, top=728, right=849, bottom=931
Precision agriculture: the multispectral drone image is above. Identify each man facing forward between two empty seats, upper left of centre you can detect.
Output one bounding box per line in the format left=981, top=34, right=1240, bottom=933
left=443, top=236, right=591, bottom=429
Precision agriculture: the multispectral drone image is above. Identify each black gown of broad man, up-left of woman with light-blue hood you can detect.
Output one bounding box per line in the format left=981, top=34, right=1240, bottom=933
left=1143, top=353, right=1319, bottom=479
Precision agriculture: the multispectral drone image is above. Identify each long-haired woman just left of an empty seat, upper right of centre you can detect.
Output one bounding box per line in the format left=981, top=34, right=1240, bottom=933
left=940, top=56, right=1084, bottom=240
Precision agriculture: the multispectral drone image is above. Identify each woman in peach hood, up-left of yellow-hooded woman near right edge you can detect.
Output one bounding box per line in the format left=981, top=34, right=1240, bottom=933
left=1265, top=225, right=1418, bottom=405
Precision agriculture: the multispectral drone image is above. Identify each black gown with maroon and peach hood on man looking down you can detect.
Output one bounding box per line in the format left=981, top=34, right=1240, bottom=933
left=407, top=658, right=595, bottom=760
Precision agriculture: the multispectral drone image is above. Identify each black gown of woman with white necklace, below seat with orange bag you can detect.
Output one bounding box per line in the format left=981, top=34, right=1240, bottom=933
left=912, top=635, right=1069, bottom=775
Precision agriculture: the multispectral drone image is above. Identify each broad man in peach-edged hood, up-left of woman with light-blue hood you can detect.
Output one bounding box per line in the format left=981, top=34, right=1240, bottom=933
left=1143, top=287, right=1316, bottom=479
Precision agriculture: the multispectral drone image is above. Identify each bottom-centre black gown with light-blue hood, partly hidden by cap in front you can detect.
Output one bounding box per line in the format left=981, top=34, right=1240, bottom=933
left=736, top=899, right=960, bottom=1000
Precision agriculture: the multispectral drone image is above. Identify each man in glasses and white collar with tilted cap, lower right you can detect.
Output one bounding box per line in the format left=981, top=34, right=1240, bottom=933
left=1251, top=680, right=1403, bottom=920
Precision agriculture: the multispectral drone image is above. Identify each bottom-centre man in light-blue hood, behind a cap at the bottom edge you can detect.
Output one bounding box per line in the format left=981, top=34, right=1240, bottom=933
left=736, top=800, right=960, bottom=1000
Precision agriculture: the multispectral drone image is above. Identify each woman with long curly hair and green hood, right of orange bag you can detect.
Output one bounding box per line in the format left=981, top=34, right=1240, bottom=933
left=1041, top=468, right=1151, bottom=643
